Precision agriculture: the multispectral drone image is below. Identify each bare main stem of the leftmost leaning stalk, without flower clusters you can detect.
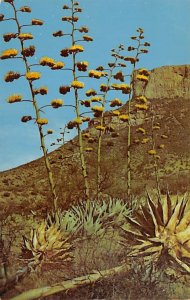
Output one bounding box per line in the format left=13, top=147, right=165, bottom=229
left=10, top=3, right=58, bottom=211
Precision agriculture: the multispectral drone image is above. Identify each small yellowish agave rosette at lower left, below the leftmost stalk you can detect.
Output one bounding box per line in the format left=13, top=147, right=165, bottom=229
left=22, top=221, right=73, bottom=262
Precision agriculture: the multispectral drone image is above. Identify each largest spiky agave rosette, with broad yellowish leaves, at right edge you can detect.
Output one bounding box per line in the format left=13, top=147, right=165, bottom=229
left=121, top=194, right=190, bottom=273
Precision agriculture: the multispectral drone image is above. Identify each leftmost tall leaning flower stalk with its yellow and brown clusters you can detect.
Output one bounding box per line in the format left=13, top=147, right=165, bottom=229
left=0, top=0, right=67, bottom=210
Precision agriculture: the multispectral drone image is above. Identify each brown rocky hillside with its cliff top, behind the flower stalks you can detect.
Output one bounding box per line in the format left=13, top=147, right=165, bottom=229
left=0, top=65, right=190, bottom=212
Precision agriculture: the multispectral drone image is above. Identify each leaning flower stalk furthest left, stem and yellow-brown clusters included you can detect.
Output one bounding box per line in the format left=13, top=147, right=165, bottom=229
left=1, top=0, right=58, bottom=211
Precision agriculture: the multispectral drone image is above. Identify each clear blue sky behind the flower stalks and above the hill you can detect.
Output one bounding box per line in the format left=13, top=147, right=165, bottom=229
left=0, top=0, right=190, bottom=171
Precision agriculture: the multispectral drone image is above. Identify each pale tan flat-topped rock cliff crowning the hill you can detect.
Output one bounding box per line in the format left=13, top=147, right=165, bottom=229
left=134, top=65, right=190, bottom=99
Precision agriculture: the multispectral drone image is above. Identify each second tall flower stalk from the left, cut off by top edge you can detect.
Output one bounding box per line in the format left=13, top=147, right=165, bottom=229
left=53, top=0, right=93, bottom=199
